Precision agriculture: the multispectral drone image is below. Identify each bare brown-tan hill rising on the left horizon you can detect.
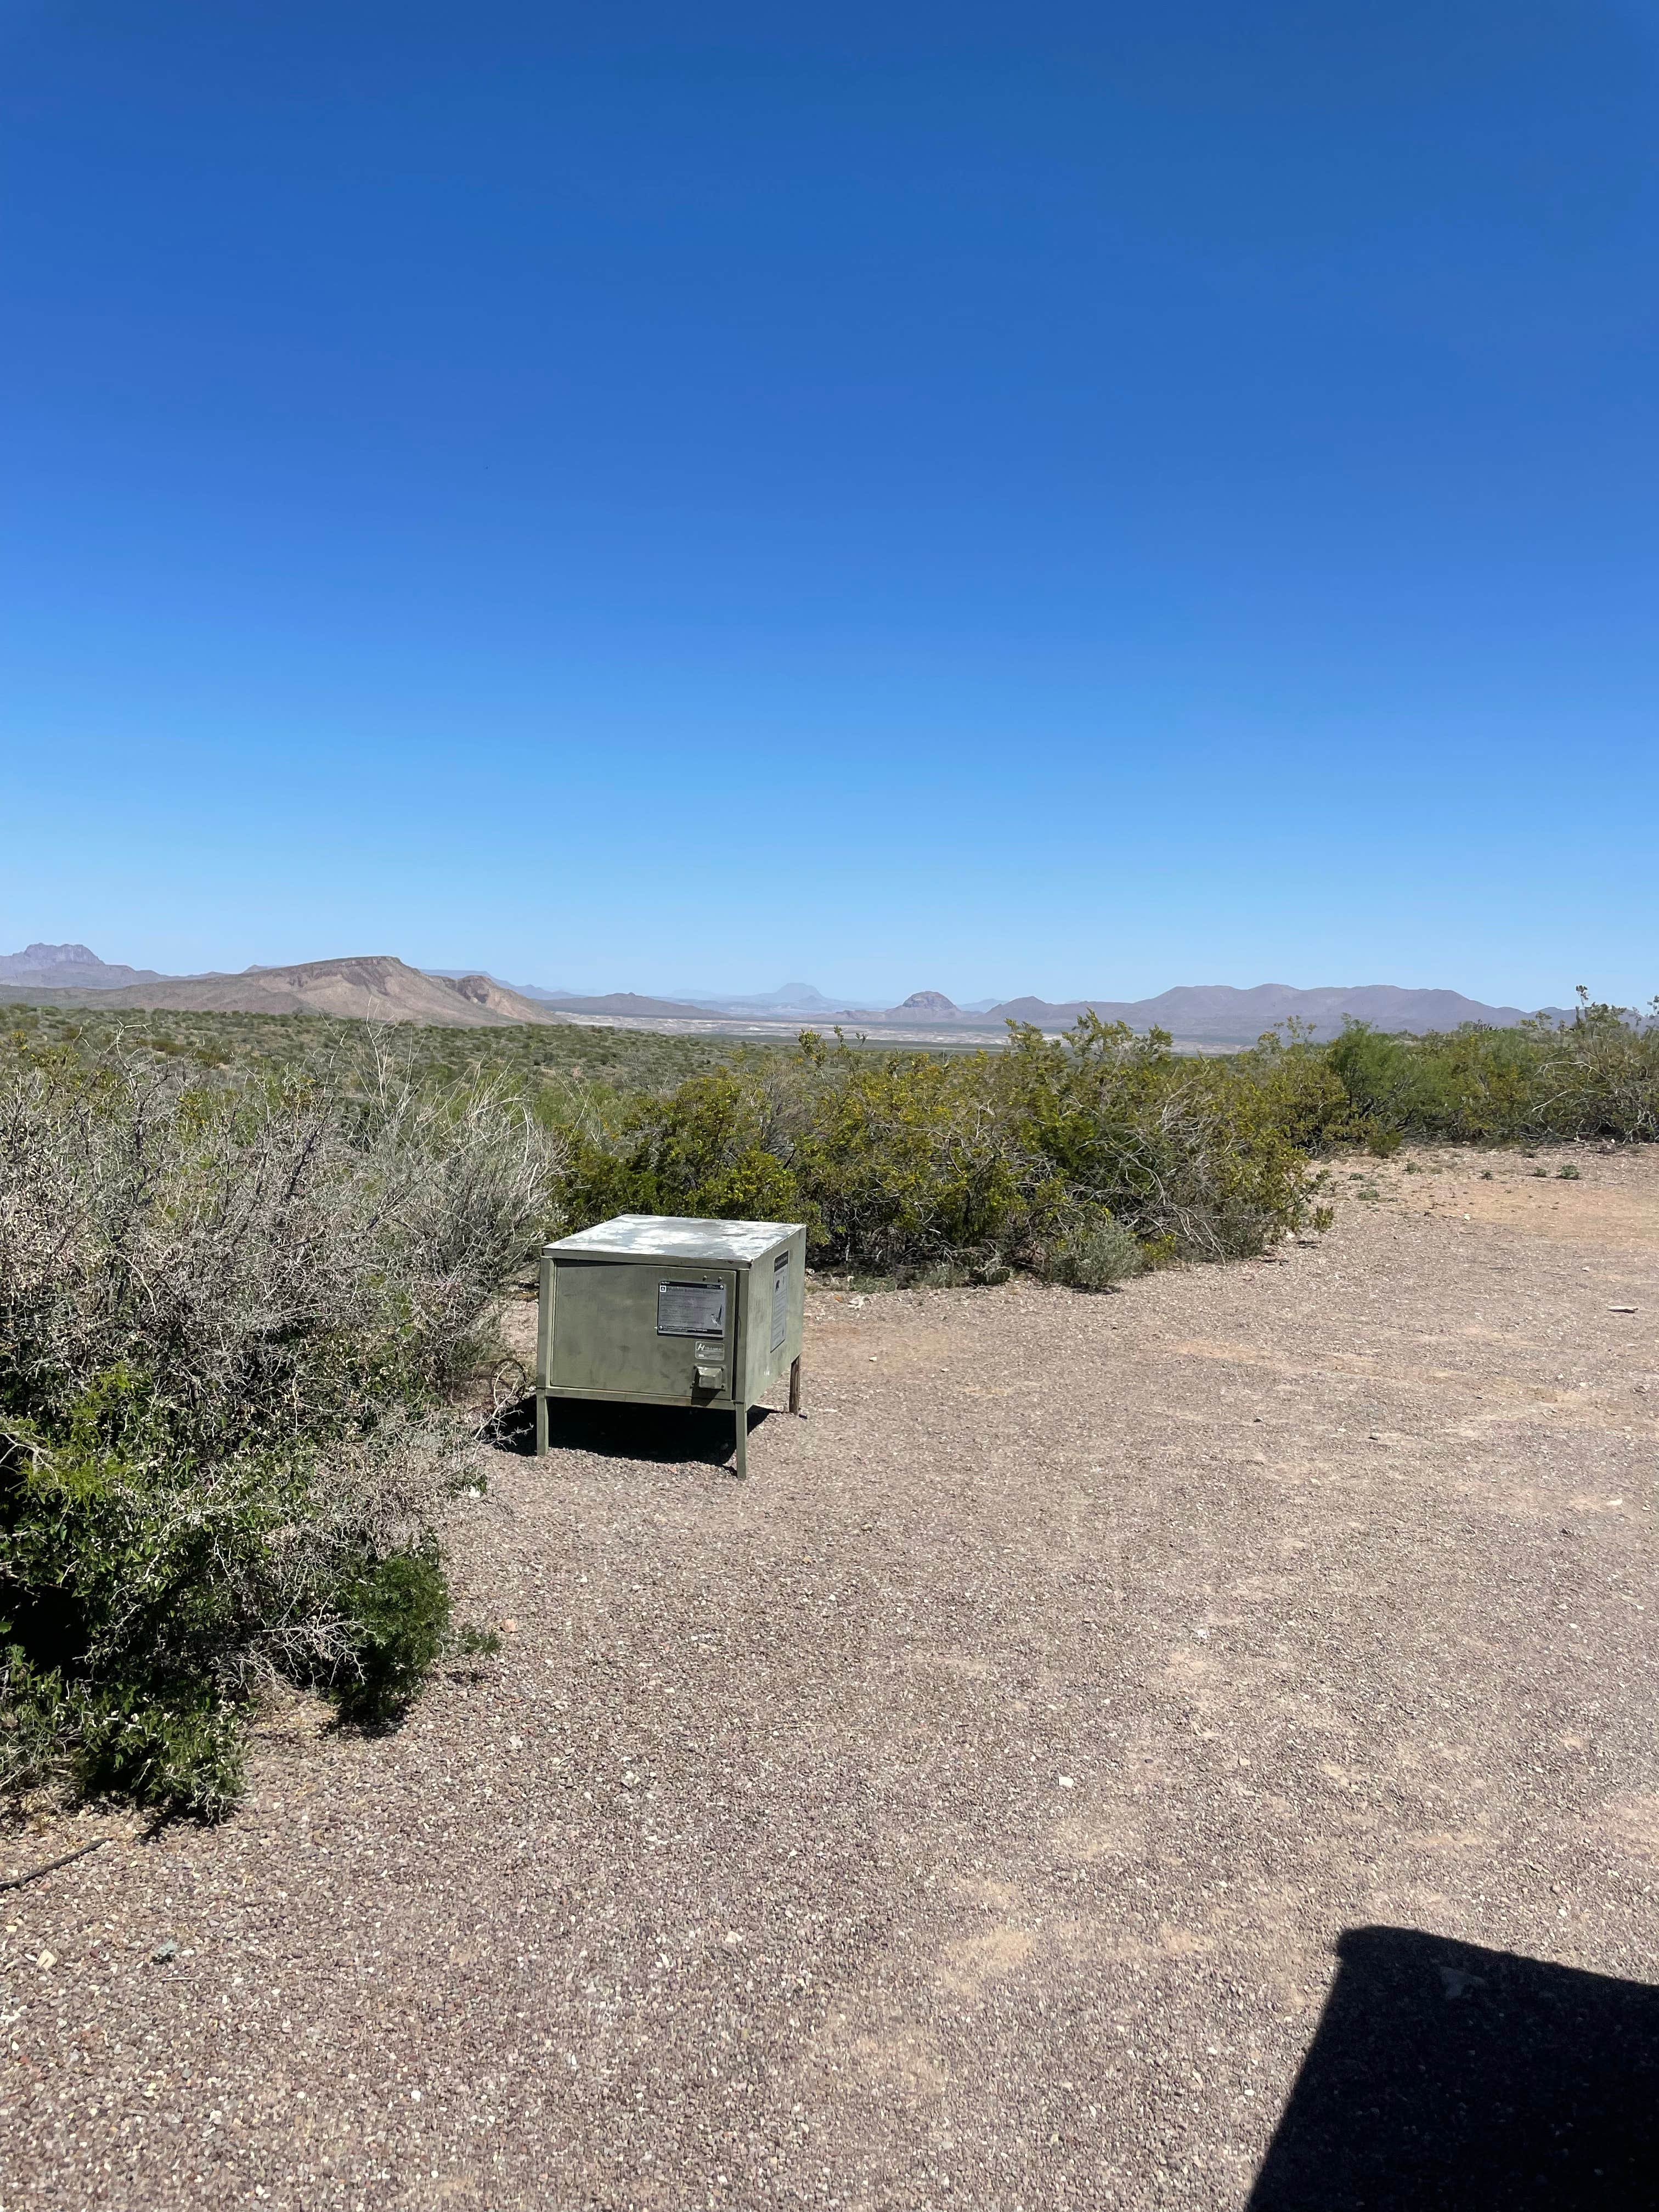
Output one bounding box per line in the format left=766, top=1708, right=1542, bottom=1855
left=7, top=953, right=564, bottom=1029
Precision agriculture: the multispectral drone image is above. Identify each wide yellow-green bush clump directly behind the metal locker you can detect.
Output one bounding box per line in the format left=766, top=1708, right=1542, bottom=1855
left=560, top=1018, right=1340, bottom=1288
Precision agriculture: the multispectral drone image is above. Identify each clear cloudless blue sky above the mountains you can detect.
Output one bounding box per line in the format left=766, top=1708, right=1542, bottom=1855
left=0, top=0, right=1659, bottom=1005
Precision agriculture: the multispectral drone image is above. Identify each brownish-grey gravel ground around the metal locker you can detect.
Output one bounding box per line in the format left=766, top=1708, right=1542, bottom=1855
left=0, top=1148, right=1659, bottom=2212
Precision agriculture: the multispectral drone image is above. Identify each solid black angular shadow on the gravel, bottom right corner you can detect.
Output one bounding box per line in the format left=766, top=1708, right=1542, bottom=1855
left=1248, top=1929, right=1659, bottom=2212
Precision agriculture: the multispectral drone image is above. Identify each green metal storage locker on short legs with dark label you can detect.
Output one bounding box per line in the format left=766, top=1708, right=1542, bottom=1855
left=535, top=1215, right=808, bottom=1475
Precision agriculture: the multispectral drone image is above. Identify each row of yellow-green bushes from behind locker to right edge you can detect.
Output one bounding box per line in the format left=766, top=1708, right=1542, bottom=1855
left=560, top=997, right=1659, bottom=1290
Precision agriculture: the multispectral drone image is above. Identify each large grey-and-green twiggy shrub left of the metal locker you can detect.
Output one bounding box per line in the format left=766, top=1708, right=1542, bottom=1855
left=0, top=1062, right=560, bottom=1814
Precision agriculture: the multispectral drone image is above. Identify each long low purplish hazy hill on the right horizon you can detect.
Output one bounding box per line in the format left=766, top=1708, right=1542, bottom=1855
left=991, top=982, right=1555, bottom=1044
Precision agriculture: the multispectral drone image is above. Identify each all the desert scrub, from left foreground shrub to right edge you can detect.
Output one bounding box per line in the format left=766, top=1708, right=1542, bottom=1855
left=0, top=1005, right=1659, bottom=1814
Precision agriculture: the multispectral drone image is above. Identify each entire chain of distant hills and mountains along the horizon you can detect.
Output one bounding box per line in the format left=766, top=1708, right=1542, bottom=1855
left=0, top=945, right=1566, bottom=1046
